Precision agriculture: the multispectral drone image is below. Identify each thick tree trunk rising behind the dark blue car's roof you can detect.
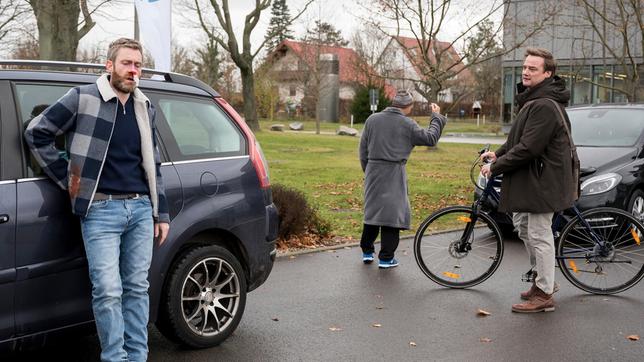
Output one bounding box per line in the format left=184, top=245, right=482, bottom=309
left=30, top=0, right=80, bottom=61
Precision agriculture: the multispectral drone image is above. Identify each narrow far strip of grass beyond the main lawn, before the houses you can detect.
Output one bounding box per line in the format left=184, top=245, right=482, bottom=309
left=259, top=117, right=501, bottom=134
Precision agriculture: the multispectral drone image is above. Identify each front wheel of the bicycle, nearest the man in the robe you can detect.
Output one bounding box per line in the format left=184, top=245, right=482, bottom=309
left=414, top=206, right=503, bottom=288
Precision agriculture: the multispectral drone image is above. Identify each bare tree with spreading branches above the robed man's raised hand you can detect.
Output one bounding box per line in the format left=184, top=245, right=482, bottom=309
left=366, top=0, right=557, bottom=104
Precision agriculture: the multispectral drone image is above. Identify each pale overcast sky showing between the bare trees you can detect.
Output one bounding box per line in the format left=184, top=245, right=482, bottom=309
left=79, top=0, right=499, bottom=58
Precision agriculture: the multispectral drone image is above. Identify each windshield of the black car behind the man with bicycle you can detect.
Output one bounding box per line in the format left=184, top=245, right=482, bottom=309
left=568, top=108, right=644, bottom=147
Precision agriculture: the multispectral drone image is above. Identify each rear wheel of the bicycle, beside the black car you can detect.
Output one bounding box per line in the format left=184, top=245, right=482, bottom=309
left=557, top=207, right=644, bottom=294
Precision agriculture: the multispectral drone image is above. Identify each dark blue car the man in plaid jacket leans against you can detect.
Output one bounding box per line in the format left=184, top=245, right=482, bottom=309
left=0, top=61, right=278, bottom=349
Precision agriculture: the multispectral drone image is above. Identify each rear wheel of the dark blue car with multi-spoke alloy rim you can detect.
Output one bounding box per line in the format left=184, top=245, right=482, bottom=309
left=157, top=245, right=247, bottom=348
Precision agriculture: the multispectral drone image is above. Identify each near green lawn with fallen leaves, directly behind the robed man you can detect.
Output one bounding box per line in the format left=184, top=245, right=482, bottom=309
left=256, top=132, right=481, bottom=239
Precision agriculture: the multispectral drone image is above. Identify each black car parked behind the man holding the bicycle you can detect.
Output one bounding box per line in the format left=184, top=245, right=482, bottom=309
left=475, top=104, right=644, bottom=231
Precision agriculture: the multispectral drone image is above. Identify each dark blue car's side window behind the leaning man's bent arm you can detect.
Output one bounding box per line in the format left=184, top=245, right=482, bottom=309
left=15, top=84, right=71, bottom=177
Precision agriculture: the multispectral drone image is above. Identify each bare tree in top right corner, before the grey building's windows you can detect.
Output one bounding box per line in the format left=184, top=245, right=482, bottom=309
left=577, top=0, right=644, bottom=102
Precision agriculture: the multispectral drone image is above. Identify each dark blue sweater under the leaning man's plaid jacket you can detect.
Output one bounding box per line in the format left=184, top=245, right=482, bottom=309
left=97, top=96, right=150, bottom=194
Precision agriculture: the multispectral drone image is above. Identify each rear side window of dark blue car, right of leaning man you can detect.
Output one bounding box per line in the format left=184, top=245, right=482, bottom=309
left=157, top=96, right=246, bottom=161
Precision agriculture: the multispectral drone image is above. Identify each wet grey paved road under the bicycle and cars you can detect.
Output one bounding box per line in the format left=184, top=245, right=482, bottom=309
left=7, top=236, right=644, bottom=361
